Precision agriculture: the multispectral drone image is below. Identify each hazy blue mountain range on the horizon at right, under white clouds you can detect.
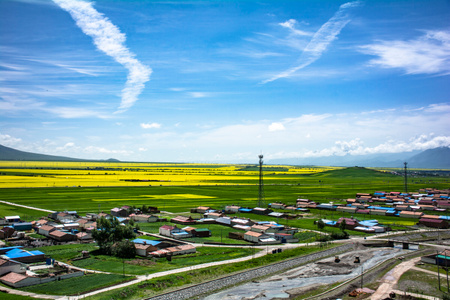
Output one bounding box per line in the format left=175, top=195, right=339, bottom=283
left=266, top=147, right=450, bottom=169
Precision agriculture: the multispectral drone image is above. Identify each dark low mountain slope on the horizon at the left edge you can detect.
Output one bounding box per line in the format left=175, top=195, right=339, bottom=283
left=0, top=145, right=118, bottom=161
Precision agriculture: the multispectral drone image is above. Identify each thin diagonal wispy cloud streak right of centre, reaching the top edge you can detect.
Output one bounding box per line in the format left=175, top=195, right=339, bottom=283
left=262, top=1, right=360, bottom=84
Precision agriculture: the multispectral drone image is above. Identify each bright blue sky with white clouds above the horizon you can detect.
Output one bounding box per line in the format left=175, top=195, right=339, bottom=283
left=0, top=0, right=450, bottom=162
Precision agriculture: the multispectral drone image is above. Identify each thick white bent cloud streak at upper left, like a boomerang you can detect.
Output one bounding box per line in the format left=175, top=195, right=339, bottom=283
left=53, top=0, right=152, bottom=112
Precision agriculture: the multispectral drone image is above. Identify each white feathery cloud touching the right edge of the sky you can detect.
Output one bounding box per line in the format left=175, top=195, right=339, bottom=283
left=359, top=30, right=450, bottom=75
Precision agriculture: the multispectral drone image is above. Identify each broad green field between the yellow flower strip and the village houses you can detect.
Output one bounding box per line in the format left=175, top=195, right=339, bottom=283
left=0, top=168, right=449, bottom=217
